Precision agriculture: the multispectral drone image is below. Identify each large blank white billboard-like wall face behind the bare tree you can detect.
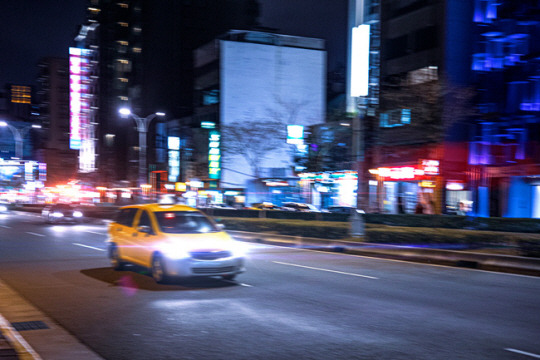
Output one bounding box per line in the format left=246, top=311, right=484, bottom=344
left=220, top=40, right=326, bottom=188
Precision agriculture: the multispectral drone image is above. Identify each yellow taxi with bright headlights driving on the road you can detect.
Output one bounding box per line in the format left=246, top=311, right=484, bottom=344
left=107, top=204, right=245, bottom=283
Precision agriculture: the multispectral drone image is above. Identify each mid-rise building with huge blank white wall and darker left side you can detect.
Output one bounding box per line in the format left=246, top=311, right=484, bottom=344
left=193, top=30, right=326, bottom=203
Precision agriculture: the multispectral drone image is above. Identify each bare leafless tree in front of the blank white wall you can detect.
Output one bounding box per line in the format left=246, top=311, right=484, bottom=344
left=221, top=120, right=286, bottom=179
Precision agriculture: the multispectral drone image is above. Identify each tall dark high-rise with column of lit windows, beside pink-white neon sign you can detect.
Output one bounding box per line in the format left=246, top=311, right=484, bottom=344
left=76, top=0, right=258, bottom=183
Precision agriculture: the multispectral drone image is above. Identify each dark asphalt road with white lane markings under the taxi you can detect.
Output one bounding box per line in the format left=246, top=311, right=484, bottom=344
left=0, top=213, right=540, bottom=360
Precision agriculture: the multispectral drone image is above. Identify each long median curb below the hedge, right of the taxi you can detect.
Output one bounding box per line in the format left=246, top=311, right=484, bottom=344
left=227, top=231, right=540, bottom=276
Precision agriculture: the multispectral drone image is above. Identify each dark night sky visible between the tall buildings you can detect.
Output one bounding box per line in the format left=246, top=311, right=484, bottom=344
left=0, top=0, right=347, bottom=88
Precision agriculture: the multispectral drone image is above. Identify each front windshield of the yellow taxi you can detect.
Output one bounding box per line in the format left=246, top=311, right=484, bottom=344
left=155, top=211, right=221, bottom=234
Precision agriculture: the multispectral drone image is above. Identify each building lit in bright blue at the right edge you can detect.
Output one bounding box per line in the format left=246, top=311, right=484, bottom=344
left=468, top=0, right=540, bottom=218
